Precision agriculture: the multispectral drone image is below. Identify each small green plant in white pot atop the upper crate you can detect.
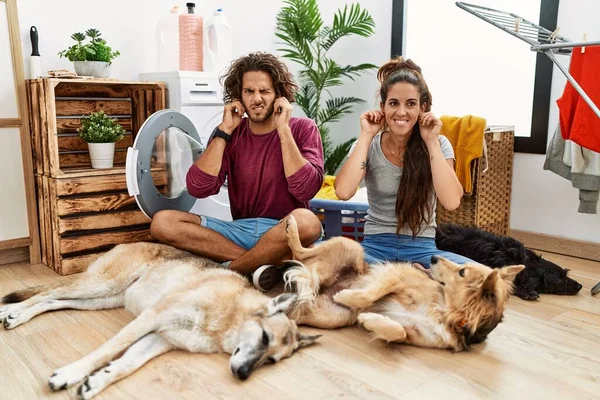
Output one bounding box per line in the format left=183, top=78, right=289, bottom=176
left=58, top=29, right=121, bottom=78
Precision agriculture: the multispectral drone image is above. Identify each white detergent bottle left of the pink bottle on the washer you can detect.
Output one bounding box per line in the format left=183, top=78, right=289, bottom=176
left=156, top=6, right=181, bottom=72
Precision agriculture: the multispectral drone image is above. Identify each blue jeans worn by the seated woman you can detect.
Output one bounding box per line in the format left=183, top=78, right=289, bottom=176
left=362, top=233, right=473, bottom=268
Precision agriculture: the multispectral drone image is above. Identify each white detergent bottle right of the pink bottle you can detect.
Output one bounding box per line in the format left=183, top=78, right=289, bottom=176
left=204, top=8, right=233, bottom=75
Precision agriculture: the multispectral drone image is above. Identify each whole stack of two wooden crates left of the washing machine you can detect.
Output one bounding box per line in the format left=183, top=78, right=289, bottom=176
left=26, top=78, right=166, bottom=275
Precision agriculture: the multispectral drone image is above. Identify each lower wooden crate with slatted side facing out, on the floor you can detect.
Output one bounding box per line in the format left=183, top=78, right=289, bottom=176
left=36, top=173, right=153, bottom=275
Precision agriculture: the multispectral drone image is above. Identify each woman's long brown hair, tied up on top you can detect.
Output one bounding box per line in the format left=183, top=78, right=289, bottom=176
left=377, top=57, right=434, bottom=237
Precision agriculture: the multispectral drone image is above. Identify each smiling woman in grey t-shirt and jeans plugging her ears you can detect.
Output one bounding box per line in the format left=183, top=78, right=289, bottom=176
left=335, top=57, right=470, bottom=268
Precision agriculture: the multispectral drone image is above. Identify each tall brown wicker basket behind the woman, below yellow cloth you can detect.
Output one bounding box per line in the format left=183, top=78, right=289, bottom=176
left=436, top=131, right=514, bottom=235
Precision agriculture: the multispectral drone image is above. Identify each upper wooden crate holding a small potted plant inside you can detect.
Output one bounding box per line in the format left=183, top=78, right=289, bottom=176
left=26, top=78, right=165, bottom=177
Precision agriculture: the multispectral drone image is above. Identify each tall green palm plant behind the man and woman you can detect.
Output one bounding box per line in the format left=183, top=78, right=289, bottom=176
left=275, top=0, right=377, bottom=174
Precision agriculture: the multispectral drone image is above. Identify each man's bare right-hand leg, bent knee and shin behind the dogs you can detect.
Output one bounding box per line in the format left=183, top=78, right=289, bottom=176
left=229, top=208, right=321, bottom=274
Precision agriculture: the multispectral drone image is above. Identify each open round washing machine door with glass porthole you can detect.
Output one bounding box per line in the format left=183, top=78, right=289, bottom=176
left=125, top=110, right=205, bottom=218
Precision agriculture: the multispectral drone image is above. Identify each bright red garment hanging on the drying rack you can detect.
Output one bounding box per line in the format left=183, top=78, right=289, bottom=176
left=556, top=46, right=600, bottom=152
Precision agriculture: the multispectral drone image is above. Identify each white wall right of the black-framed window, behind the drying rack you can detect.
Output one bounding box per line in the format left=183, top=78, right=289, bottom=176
left=510, top=0, right=600, bottom=243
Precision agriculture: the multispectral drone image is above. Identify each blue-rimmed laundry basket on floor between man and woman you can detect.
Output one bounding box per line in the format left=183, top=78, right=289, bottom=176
left=310, top=199, right=369, bottom=242
